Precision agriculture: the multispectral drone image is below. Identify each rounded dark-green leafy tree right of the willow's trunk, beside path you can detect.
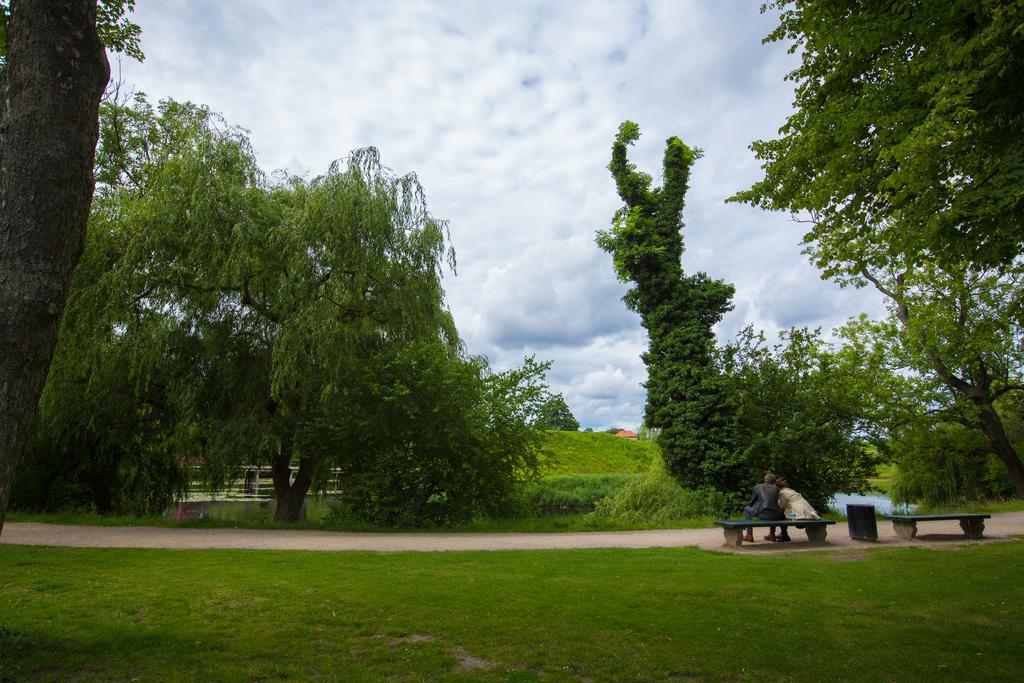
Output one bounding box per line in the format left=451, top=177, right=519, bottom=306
left=327, top=343, right=550, bottom=526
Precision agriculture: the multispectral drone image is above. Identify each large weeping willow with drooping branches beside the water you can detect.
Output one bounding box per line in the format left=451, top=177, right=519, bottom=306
left=43, top=97, right=459, bottom=521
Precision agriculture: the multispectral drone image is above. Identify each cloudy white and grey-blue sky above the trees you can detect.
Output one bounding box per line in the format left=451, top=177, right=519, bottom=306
left=114, top=0, right=881, bottom=429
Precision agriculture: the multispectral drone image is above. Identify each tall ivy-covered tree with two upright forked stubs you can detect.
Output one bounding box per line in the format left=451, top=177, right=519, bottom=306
left=597, top=121, right=742, bottom=490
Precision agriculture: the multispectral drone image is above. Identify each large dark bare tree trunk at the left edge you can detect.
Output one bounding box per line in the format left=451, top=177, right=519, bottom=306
left=0, top=0, right=110, bottom=531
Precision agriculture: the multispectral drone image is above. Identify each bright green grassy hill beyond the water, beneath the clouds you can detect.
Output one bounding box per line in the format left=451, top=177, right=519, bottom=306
left=541, top=431, right=659, bottom=475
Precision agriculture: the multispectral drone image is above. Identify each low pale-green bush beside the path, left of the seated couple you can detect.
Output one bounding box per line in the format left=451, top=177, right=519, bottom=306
left=592, top=472, right=729, bottom=525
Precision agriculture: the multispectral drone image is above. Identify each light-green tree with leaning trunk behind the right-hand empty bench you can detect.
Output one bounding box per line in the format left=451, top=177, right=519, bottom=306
left=844, top=270, right=1024, bottom=500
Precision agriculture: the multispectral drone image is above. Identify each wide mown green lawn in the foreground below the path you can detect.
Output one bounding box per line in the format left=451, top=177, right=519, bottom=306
left=0, top=542, right=1024, bottom=681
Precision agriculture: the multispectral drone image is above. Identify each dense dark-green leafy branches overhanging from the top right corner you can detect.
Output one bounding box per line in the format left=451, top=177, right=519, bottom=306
left=734, top=0, right=1024, bottom=268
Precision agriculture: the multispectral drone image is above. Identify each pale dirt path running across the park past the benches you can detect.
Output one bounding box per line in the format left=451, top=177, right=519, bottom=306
left=0, top=512, right=1024, bottom=553
